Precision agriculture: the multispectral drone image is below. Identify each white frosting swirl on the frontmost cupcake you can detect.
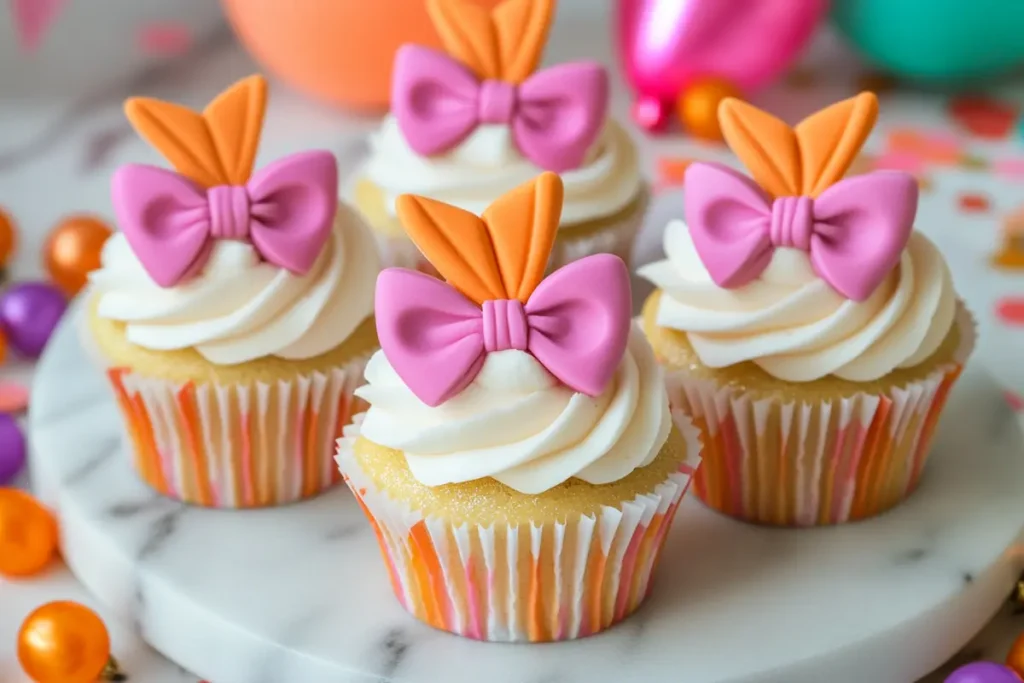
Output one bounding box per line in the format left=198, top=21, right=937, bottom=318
left=355, top=326, right=672, bottom=494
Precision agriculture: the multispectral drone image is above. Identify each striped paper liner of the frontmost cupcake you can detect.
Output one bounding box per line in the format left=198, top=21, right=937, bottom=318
left=338, top=415, right=700, bottom=642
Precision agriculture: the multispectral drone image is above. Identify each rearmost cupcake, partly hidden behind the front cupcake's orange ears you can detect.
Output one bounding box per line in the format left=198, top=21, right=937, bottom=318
left=352, top=0, right=647, bottom=269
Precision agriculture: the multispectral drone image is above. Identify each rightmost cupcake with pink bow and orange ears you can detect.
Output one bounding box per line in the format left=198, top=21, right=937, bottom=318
left=640, top=93, right=975, bottom=526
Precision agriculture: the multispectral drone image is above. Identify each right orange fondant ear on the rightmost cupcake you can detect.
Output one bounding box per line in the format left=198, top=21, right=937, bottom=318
left=795, top=92, right=879, bottom=197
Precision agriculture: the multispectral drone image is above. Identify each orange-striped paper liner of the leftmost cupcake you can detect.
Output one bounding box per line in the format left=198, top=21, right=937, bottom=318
left=106, top=357, right=367, bottom=508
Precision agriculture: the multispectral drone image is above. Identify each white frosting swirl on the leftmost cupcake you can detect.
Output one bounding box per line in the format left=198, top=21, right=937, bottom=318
left=89, top=205, right=380, bottom=366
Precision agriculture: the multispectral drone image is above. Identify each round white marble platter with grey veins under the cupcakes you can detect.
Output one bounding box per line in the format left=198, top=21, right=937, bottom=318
left=30, top=307, right=1024, bottom=683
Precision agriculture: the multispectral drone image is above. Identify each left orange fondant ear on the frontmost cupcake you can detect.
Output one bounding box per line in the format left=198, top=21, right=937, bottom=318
left=395, top=195, right=508, bottom=304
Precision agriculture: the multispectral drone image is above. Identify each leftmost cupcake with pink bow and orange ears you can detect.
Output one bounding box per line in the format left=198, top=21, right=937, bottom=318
left=87, top=77, right=380, bottom=508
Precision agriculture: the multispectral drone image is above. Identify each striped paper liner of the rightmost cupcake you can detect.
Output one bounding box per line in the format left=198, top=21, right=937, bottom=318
left=666, top=304, right=976, bottom=526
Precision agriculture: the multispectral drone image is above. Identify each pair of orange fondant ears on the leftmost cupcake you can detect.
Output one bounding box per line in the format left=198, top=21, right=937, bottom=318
left=125, top=76, right=266, bottom=187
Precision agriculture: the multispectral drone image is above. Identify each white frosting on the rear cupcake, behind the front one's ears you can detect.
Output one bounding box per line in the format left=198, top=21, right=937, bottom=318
left=366, top=116, right=641, bottom=225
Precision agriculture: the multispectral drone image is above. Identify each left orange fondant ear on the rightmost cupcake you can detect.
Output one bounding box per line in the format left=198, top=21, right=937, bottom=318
left=718, top=97, right=803, bottom=197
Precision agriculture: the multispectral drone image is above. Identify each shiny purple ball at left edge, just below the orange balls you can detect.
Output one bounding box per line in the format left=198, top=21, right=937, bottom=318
left=0, top=282, right=68, bottom=358
